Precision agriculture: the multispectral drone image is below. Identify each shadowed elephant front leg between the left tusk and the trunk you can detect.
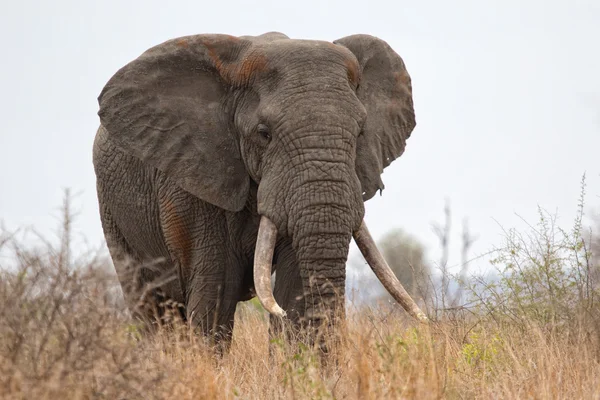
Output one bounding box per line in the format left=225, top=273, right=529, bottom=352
left=269, top=239, right=306, bottom=336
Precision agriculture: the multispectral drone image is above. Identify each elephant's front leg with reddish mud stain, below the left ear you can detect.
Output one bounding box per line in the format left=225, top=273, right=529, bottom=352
left=160, top=185, right=243, bottom=350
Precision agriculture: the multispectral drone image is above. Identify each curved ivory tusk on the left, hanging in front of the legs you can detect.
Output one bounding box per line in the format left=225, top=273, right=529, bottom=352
left=254, top=215, right=285, bottom=318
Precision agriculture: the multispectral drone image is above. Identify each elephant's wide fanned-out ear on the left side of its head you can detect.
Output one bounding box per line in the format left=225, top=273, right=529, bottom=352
left=98, top=35, right=250, bottom=211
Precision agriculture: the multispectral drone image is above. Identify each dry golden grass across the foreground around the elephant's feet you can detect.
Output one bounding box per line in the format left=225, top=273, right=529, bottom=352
left=0, top=260, right=600, bottom=399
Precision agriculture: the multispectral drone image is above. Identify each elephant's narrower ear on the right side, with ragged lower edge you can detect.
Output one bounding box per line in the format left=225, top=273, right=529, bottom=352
left=334, top=35, right=416, bottom=201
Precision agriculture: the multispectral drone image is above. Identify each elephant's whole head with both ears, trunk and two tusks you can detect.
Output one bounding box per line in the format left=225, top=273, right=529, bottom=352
left=99, top=33, right=427, bottom=332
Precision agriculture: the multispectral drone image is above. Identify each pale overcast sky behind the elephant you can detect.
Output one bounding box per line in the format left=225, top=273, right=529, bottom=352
left=0, top=0, right=600, bottom=276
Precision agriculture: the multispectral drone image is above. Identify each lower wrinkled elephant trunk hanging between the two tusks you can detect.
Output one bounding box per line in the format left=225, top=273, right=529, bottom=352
left=290, top=180, right=356, bottom=327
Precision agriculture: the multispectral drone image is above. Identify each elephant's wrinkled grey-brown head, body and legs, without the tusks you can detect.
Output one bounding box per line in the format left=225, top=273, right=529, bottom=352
left=94, top=33, right=415, bottom=348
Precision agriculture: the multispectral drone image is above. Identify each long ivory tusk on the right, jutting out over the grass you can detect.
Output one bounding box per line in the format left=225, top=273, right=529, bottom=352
left=354, top=221, right=429, bottom=323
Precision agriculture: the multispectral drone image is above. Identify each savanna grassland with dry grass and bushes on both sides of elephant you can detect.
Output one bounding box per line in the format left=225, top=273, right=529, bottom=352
left=0, top=186, right=600, bottom=399
